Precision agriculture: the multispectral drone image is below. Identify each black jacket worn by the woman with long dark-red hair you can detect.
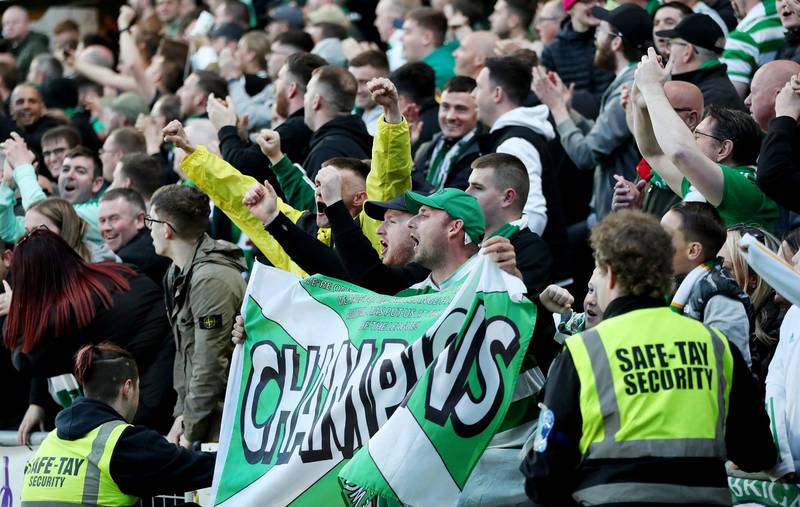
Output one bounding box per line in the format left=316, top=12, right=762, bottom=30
left=14, top=274, right=175, bottom=431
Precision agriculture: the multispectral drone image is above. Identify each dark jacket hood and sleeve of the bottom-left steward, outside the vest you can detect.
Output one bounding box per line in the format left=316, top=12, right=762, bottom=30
left=56, top=398, right=216, bottom=497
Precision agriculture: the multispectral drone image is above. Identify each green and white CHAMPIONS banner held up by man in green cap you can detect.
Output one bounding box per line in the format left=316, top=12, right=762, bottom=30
left=212, top=255, right=540, bottom=507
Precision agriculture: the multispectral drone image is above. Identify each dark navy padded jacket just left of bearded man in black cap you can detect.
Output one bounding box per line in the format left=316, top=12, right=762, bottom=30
left=541, top=22, right=614, bottom=96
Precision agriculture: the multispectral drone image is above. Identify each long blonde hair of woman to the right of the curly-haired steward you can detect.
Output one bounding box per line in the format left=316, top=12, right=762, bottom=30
left=725, top=226, right=780, bottom=344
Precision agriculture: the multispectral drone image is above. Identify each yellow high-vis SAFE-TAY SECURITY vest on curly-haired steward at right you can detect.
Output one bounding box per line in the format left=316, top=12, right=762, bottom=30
left=566, top=307, right=733, bottom=505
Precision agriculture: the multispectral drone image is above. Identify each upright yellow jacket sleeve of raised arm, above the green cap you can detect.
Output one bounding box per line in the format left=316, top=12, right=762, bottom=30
left=359, top=115, right=414, bottom=252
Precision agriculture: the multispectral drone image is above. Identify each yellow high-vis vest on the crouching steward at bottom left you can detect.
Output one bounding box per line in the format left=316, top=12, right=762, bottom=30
left=22, top=421, right=139, bottom=507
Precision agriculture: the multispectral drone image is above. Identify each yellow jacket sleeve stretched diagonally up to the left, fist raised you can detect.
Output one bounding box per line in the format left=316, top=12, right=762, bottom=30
left=181, top=146, right=308, bottom=277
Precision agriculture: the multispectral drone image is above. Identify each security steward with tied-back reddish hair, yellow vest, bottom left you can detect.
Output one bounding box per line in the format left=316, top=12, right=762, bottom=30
left=22, top=342, right=215, bottom=507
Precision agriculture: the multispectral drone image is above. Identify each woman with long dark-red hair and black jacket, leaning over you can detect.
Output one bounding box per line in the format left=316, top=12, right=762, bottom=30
left=4, top=227, right=175, bottom=442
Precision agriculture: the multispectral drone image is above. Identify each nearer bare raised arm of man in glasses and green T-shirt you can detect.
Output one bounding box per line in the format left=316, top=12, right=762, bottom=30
left=636, top=48, right=730, bottom=206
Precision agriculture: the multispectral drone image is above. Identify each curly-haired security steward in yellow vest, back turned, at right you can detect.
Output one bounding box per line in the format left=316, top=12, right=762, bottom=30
left=522, top=211, right=776, bottom=507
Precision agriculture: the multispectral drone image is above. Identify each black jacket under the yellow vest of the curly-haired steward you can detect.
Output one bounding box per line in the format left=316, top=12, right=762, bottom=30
left=521, top=296, right=775, bottom=506
